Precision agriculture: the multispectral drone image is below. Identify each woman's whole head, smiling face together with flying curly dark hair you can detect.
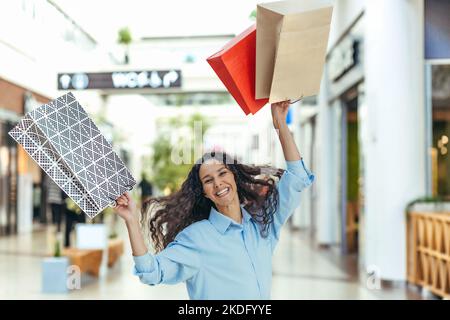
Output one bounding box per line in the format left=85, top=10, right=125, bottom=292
left=146, top=152, right=283, bottom=251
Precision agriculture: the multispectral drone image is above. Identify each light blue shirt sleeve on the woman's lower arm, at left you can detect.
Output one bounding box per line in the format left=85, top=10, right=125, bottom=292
left=133, top=232, right=200, bottom=285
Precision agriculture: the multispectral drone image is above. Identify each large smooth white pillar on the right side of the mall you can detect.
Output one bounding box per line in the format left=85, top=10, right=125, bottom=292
left=364, top=0, right=426, bottom=281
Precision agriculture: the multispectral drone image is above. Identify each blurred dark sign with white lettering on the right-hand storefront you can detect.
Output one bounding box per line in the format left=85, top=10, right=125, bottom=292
left=329, top=38, right=359, bottom=81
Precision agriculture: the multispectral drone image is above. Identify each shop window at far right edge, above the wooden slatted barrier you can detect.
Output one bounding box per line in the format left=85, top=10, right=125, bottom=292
left=425, top=0, right=450, bottom=199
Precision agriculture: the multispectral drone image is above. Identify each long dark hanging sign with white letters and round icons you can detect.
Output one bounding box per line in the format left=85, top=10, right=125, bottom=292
left=58, top=70, right=181, bottom=90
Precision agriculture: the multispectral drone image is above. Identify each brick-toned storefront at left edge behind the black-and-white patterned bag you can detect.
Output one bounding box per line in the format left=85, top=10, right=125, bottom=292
left=0, top=79, right=49, bottom=236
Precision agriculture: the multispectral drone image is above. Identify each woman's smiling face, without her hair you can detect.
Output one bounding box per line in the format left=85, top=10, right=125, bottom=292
left=199, top=159, right=237, bottom=207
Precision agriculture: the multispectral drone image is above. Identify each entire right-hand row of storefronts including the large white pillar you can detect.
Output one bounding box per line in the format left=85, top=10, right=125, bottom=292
left=299, top=0, right=450, bottom=282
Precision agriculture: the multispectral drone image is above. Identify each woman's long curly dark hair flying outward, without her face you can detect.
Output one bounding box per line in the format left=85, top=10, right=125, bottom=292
left=141, top=152, right=283, bottom=252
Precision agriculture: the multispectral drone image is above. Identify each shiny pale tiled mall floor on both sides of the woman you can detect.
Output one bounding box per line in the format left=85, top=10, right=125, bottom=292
left=0, top=222, right=428, bottom=299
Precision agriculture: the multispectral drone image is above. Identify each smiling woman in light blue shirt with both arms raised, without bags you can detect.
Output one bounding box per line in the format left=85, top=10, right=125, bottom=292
left=116, top=102, right=314, bottom=299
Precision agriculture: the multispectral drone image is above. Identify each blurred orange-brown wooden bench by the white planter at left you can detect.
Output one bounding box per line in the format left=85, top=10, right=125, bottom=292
left=62, top=239, right=124, bottom=277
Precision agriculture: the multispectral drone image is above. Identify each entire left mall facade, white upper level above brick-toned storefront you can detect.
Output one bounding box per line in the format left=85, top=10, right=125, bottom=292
left=0, top=1, right=108, bottom=236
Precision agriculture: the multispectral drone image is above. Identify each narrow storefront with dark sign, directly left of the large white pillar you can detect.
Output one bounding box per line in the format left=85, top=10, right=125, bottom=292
left=326, top=14, right=364, bottom=253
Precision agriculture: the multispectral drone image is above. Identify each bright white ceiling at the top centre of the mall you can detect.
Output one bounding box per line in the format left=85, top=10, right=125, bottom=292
left=52, top=0, right=266, bottom=43
